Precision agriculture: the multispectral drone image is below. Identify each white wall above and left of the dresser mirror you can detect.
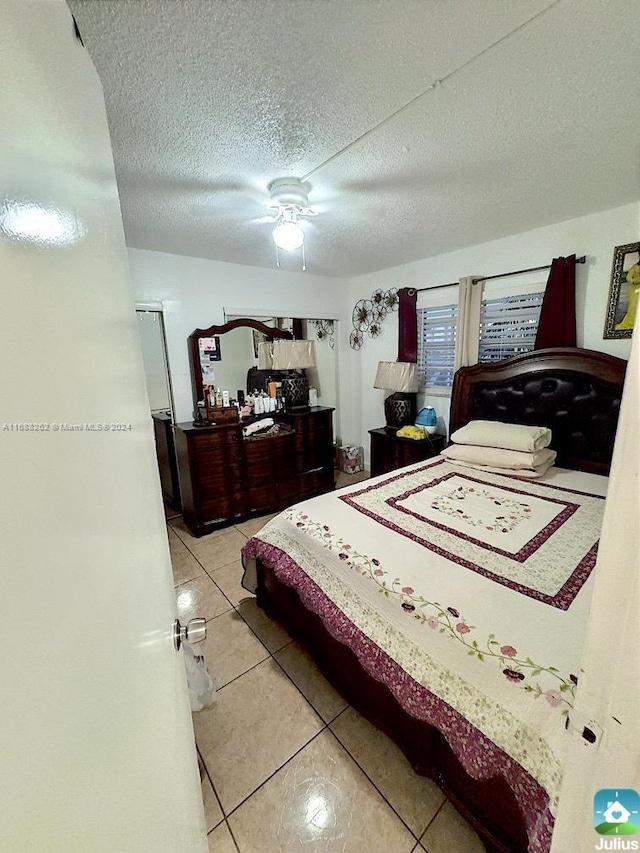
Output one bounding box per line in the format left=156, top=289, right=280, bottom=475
left=129, top=249, right=350, bottom=430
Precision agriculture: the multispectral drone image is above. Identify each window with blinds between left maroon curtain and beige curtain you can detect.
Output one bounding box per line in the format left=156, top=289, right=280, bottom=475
left=418, top=304, right=458, bottom=388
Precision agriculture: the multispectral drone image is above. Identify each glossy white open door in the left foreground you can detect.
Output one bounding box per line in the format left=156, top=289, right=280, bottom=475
left=0, top=0, right=207, bottom=853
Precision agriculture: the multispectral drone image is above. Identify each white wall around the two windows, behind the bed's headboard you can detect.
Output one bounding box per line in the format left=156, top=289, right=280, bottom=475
left=348, top=203, right=640, bottom=459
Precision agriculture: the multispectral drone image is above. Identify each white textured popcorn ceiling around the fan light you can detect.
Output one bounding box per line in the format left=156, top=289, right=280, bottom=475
left=68, top=0, right=640, bottom=276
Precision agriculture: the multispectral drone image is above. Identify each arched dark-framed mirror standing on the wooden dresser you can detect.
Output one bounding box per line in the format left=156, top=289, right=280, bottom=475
left=189, top=317, right=293, bottom=409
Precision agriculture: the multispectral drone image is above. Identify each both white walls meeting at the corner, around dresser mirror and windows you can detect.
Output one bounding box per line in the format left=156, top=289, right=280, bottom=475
left=129, top=203, right=640, bottom=459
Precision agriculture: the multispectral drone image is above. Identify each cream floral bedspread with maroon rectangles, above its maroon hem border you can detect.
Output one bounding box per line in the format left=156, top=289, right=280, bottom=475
left=242, top=457, right=607, bottom=824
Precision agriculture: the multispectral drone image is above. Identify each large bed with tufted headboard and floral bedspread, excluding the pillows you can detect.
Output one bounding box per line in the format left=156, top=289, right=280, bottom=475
left=243, top=349, right=626, bottom=853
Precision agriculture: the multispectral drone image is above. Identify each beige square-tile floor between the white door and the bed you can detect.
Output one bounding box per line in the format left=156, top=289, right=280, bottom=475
left=167, top=472, right=484, bottom=853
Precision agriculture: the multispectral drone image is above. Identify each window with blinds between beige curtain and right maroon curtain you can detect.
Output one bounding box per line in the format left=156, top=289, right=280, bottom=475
left=478, top=292, right=544, bottom=361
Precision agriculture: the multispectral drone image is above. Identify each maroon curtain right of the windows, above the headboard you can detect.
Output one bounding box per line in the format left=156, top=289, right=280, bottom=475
left=534, top=255, right=576, bottom=349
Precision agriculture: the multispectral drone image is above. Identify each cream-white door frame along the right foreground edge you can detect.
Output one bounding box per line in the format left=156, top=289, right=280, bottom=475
left=551, top=324, right=640, bottom=853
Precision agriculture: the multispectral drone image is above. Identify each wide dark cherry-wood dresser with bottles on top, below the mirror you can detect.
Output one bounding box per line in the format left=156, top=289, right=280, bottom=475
left=175, top=406, right=334, bottom=536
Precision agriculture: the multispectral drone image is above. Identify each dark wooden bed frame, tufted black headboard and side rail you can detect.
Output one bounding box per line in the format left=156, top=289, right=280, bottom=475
left=257, top=349, right=626, bottom=853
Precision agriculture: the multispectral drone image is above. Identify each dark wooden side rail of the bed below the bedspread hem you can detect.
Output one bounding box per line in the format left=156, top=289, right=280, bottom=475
left=250, top=540, right=551, bottom=853
